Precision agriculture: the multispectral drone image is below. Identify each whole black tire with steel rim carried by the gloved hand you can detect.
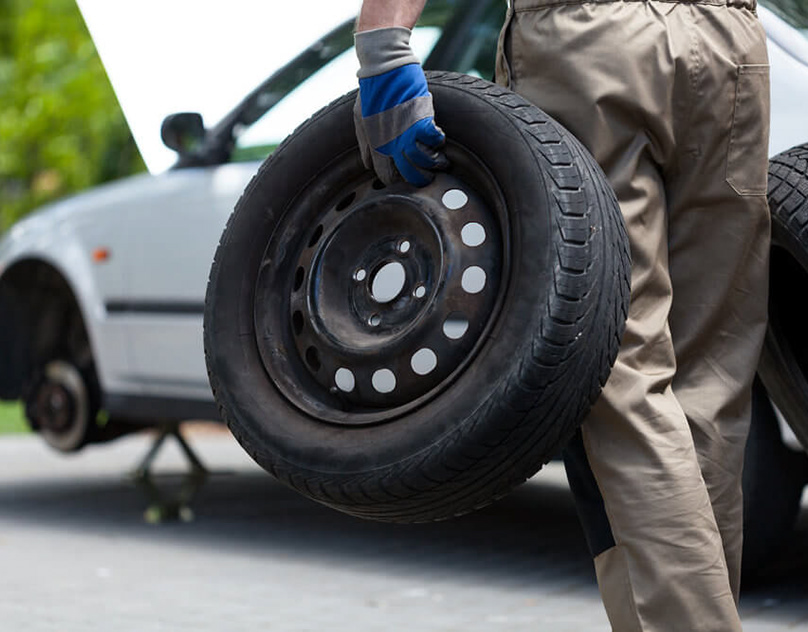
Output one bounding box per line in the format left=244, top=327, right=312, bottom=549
left=205, top=73, right=630, bottom=522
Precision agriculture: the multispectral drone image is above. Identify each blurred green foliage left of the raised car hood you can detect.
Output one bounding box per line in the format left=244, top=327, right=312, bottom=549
left=0, top=0, right=144, bottom=232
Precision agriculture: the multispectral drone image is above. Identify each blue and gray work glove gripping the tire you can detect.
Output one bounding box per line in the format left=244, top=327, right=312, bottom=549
left=354, top=26, right=448, bottom=186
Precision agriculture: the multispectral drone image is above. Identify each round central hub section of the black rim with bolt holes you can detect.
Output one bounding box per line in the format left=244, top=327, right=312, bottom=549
left=306, top=196, right=444, bottom=352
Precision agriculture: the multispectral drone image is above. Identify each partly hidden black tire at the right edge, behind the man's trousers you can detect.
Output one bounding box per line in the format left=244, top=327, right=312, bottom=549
left=758, top=144, right=808, bottom=449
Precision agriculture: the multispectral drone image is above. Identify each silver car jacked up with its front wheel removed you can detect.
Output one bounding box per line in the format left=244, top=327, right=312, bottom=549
left=0, top=0, right=808, bottom=572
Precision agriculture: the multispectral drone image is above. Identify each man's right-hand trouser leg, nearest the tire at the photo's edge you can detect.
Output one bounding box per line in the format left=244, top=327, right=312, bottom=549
left=668, top=6, right=769, bottom=601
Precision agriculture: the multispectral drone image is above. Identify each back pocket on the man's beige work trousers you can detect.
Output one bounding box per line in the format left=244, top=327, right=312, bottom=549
left=726, top=64, right=769, bottom=195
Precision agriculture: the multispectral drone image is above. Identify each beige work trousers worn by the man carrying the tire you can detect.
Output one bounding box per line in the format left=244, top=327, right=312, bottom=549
left=497, top=0, right=769, bottom=632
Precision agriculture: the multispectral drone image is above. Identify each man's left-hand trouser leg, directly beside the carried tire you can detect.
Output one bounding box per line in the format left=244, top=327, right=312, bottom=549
left=500, top=0, right=760, bottom=631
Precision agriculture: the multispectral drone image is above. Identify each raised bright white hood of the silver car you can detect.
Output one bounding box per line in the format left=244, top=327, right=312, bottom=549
left=77, top=0, right=361, bottom=173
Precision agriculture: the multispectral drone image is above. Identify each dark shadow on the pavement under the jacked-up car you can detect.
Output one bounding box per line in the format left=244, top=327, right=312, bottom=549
left=0, top=434, right=808, bottom=620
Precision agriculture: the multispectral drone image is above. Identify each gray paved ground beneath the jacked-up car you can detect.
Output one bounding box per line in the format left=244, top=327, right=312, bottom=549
left=0, top=428, right=808, bottom=632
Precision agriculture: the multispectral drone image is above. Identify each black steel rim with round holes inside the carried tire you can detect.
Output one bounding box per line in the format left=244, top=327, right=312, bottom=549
left=253, top=145, right=510, bottom=425
